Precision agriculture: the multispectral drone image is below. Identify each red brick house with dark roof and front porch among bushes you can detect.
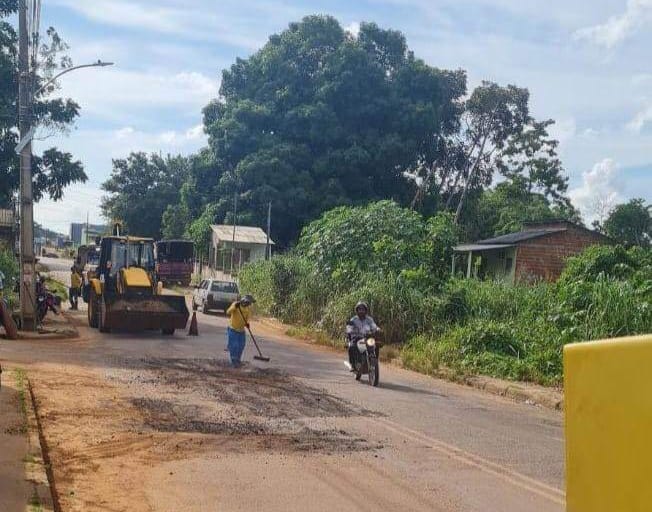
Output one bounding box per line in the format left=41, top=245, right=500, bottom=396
left=453, top=221, right=611, bottom=283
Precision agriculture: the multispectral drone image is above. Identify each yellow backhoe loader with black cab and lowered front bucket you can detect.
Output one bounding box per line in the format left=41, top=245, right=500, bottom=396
left=88, top=234, right=190, bottom=335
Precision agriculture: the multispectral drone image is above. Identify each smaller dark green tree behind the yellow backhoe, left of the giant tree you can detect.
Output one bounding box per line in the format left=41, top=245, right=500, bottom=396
left=102, top=153, right=189, bottom=238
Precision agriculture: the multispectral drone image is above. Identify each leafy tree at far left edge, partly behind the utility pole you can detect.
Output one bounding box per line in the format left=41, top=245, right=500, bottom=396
left=0, top=0, right=87, bottom=205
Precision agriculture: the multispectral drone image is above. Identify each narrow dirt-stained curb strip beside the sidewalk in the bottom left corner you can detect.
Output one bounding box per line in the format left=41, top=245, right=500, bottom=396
left=25, top=378, right=61, bottom=512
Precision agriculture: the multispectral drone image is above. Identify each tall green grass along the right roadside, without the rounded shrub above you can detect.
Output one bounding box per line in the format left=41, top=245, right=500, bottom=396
left=240, top=247, right=652, bottom=384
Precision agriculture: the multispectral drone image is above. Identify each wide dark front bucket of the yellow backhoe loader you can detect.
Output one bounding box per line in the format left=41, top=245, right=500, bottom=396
left=103, top=295, right=190, bottom=331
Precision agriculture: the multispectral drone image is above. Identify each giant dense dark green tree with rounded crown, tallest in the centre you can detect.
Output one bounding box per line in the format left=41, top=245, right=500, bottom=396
left=204, top=16, right=466, bottom=244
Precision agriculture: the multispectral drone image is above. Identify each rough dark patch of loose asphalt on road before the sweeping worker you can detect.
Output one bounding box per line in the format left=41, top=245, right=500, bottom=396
left=110, top=358, right=382, bottom=453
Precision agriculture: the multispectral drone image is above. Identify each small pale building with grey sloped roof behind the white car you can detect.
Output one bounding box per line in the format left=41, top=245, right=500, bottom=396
left=208, top=224, right=274, bottom=274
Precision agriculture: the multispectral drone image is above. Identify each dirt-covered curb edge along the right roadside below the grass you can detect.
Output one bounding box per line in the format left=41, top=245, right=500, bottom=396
left=256, top=317, right=564, bottom=411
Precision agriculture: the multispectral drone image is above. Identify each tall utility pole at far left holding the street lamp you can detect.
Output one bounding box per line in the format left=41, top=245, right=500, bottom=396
left=18, top=0, right=36, bottom=331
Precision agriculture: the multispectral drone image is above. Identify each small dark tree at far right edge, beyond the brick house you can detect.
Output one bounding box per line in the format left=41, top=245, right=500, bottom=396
left=603, top=199, right=652, bottom=247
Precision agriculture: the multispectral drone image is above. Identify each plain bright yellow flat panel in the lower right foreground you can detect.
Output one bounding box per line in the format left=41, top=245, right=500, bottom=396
left=564, top=335, right=652, bottom=512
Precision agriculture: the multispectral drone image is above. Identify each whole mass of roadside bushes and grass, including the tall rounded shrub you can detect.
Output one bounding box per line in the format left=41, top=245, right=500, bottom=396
left=240, top=201, right=652, bottom=385
